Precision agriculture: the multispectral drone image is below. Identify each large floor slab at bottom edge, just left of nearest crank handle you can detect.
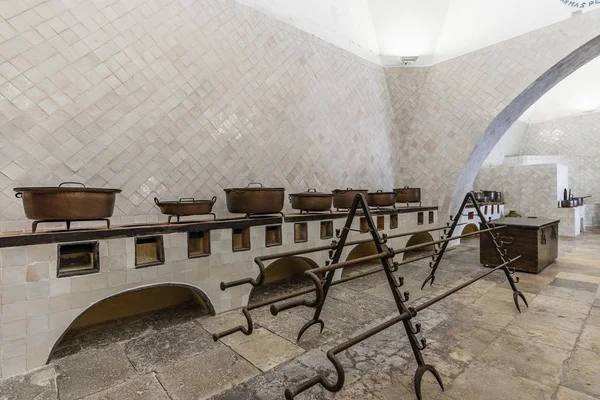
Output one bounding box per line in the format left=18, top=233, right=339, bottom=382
left=157, top=347, right=259, bottom=400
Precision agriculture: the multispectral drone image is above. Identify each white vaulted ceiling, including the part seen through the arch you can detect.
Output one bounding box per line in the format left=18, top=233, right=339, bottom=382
left=238, top=0, right=600, bottom=121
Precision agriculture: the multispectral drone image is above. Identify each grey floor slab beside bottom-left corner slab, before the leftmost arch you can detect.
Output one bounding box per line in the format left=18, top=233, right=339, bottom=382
left=56, top=344, right=136, bottom=400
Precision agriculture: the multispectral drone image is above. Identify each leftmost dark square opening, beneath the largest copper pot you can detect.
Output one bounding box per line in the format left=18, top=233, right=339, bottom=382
left=57, top=242, right=100, bottom=278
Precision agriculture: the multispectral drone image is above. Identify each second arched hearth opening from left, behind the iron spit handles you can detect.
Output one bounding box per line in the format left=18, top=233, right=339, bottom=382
left=249, top=257, right=319, bottom=304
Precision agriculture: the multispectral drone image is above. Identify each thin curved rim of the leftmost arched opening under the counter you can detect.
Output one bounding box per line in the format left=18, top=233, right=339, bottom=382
left=46, top=283, right=215, bottom=364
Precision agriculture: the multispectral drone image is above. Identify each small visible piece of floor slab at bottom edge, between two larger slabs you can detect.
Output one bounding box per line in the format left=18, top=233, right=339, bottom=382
left=82, top=374, right=170, bottom=400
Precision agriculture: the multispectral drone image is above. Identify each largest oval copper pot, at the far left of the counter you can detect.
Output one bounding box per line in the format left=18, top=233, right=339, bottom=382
left=14, top=182, right=121, bottom=222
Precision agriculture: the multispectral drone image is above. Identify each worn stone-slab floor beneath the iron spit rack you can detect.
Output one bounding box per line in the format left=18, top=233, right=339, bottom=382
left=0, top=232, right=600, bottom=400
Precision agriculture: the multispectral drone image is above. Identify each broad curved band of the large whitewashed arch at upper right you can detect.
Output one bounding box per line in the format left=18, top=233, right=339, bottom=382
left=449, top=36, right=600, bottom=214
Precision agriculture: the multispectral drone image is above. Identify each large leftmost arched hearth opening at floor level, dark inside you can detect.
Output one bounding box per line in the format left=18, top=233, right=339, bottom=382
left=48, top=284, right=215, bottom=361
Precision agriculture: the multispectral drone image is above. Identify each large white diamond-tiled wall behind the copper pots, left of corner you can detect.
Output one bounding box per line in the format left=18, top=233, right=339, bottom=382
left=0, top=0, right=393, bottom=230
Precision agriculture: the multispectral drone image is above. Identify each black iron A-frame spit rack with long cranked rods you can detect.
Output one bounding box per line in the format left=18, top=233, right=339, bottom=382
left=213, top=193, right=528, bottom=400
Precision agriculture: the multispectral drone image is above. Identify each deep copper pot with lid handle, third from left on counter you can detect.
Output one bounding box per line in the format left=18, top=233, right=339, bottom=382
left=225, top=183, right=285, bottom=214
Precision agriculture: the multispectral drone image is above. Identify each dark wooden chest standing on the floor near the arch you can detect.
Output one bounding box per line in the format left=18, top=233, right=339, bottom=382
left=480, top=218, right=560, bottom=274
